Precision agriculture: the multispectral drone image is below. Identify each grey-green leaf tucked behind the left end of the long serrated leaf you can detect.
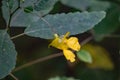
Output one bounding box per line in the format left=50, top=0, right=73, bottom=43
left=10, top=9, right=39, bottom=27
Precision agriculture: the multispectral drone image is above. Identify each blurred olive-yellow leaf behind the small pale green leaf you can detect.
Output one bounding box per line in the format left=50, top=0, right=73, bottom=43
left=82, top=44, right=114, bottom=70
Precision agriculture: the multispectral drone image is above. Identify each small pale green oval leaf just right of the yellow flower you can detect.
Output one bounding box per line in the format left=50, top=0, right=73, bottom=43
left=76, top=50, right=92, bottom=63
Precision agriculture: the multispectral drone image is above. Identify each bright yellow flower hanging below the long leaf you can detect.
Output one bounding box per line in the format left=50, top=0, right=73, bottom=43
left=49, top=32, right=81, bottom=62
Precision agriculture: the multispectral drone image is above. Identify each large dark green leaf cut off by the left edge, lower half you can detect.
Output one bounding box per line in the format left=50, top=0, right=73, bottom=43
left=0, top=30, right=17, bottom=79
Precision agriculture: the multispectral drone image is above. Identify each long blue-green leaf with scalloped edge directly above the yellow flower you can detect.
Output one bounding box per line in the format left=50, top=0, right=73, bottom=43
left=25, top=11, right=105, bottom=39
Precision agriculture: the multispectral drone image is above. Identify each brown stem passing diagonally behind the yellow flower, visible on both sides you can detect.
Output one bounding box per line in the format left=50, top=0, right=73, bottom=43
left=13, top=36, right=93, bottom=72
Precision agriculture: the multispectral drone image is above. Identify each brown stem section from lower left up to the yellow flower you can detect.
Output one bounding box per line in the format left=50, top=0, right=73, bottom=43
left=13, top=53, right=63, bottom=72
